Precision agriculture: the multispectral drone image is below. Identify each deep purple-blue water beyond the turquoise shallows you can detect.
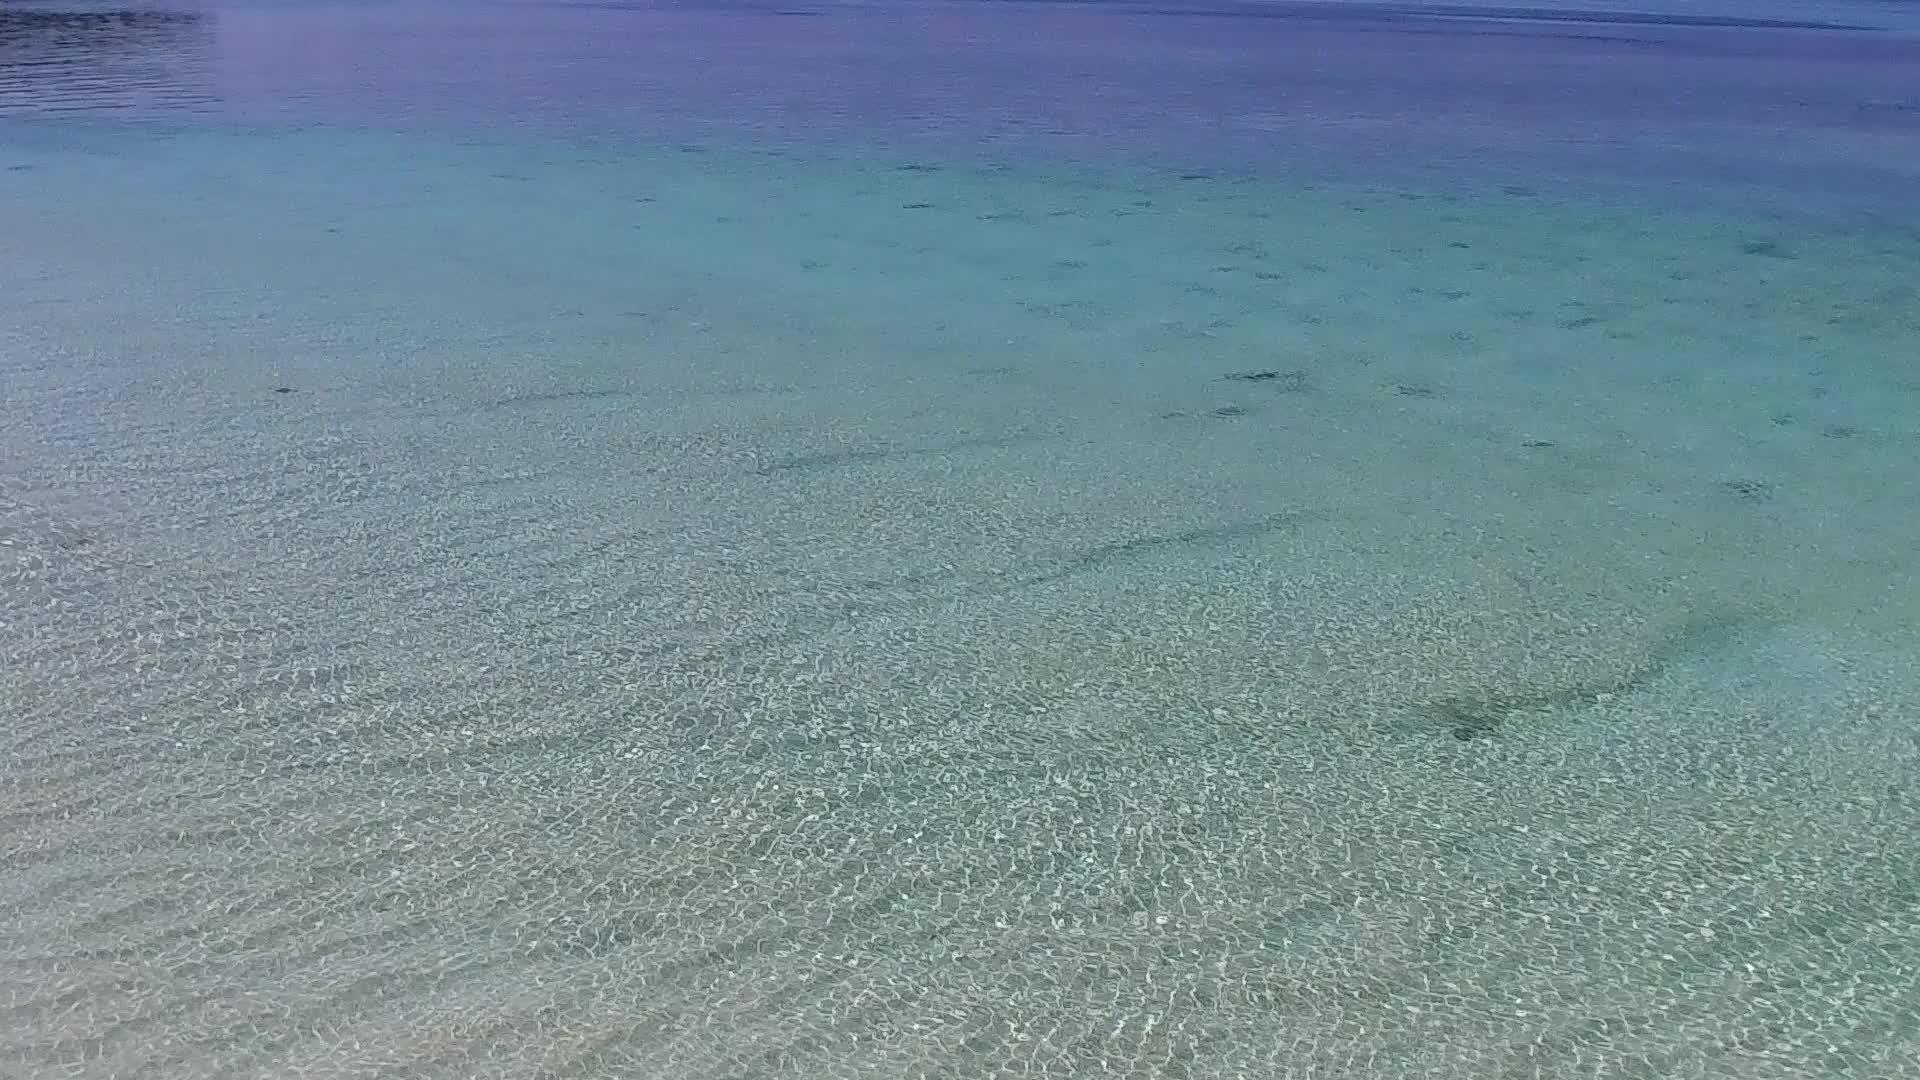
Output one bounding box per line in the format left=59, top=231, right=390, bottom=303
left=11, top=2, right=1920, bottom=215
